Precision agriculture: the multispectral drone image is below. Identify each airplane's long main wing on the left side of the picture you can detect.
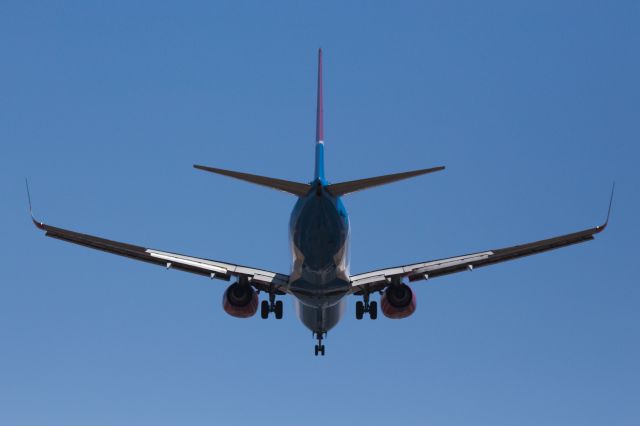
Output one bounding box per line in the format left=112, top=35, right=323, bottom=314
left=32, top=215, right=289, bottom=294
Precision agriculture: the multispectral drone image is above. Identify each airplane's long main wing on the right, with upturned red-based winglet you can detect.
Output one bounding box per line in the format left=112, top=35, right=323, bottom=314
left=350, top=189, right=613, bottom=293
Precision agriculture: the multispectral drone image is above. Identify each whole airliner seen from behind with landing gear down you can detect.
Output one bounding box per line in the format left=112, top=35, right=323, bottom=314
left=27, top=49, right=615, bottom=356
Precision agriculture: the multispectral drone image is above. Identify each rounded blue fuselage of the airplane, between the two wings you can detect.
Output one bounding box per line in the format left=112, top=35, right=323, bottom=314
left=289, top=179, right=349, bottom=333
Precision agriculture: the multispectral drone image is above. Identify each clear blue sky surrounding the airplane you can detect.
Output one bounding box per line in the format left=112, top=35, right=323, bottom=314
left=0, top=1, right=640, bottom=426
